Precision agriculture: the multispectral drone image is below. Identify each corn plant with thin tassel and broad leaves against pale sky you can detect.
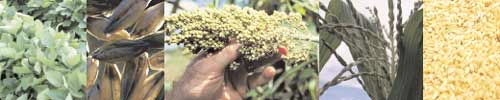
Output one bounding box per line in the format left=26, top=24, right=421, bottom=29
left=319, top=0, right=423, bottom=100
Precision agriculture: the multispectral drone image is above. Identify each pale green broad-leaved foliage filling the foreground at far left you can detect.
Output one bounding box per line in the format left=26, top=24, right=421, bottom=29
left=0, top=0, right=86, bottom=100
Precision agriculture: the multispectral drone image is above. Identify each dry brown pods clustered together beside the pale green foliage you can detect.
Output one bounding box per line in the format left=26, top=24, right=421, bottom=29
left=86, top=0, right=164, bottom=100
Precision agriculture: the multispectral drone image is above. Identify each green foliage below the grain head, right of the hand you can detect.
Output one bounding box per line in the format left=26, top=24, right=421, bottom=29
left=246, top=56, right=318, bottom=100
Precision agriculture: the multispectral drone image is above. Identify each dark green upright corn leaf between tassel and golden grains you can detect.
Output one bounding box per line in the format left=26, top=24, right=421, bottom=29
left=388, top=9, right=423, bottom=100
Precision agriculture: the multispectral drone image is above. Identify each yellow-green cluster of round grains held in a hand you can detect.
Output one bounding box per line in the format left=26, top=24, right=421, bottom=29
left=167, top=6, right=308, bottom=61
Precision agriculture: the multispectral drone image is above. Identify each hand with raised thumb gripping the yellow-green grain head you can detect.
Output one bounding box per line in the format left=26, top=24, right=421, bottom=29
left=165, top=42, right=276, bottom=100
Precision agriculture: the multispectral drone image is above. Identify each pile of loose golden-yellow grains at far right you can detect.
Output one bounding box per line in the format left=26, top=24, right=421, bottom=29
left=424, top=0, right=500, bottom=100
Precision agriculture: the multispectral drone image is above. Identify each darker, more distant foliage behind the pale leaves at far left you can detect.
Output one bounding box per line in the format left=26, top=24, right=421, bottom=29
left=7, top=0, right=87, bottom=38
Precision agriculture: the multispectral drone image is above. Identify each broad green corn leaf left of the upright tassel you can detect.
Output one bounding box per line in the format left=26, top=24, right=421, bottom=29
left=320, top=0, right=392, bottom=100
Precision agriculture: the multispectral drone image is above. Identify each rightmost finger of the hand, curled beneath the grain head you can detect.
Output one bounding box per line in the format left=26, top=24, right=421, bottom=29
left=248, top=66, right=276, bottom=88
